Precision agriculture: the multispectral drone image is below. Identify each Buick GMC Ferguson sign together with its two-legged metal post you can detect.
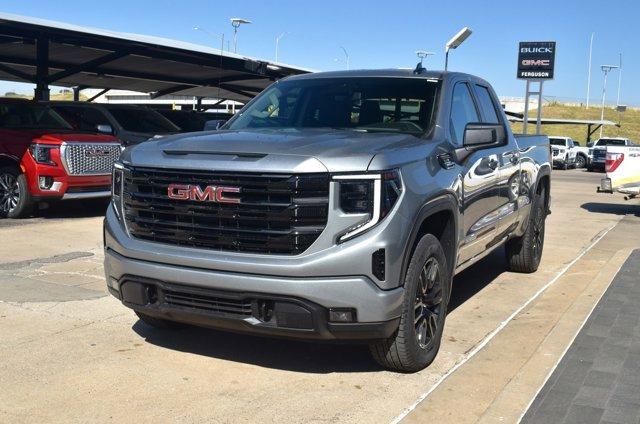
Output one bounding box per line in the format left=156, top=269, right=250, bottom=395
left=517, top=41, right=556, bottom=134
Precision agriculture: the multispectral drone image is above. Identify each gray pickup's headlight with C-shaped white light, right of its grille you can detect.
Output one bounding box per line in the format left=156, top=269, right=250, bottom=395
left=334, top=170, right=402, bottom=242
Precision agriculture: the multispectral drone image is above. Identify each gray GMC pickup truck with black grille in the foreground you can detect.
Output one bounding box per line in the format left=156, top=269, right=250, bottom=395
left=104, top=67, right=551, bottom=371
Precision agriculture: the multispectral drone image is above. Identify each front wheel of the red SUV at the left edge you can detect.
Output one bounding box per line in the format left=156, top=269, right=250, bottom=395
left=0, top=166, right=34, bottom=219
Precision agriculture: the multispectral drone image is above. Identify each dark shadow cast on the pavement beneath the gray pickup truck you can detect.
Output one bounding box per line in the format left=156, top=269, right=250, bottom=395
left=132, top=248, right=506, bottom=374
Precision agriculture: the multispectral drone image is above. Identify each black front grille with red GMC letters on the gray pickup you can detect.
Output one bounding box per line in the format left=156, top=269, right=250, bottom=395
left=123, top=168, right=329, bottom=255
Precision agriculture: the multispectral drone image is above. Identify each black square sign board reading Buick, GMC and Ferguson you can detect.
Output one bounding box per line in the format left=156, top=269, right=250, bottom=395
left=518, top=41, right=556, bottom=80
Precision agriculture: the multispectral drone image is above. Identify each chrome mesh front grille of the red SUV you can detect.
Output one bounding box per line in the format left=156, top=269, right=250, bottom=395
left=61, top=143, right=120, bottom=175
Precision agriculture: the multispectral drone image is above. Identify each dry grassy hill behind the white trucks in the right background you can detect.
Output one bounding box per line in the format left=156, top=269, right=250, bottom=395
left=511, top=103, right=640, bottom=146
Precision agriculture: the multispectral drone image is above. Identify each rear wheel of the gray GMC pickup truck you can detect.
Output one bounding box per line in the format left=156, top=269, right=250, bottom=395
left=505, top=187, right=547, bottom=273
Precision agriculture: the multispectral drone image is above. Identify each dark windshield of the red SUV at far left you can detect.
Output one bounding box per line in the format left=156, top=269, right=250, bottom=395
left=0, top=102, right=72, bottom=130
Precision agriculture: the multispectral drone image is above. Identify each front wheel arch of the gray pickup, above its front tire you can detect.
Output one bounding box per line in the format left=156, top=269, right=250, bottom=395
left=400, top=194, right=459, bottom=285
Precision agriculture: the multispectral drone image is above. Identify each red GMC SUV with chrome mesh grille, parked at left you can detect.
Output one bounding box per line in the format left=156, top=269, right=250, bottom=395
left=0, top=99, right=121, bottom=218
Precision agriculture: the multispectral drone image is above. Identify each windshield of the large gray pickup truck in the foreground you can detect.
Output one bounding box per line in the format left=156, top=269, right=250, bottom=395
left=223, top=77, right=440, bottom=135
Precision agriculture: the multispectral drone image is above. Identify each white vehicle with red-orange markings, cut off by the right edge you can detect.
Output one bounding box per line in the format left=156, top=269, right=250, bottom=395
left=598, top=146, right=640, bottom=200
